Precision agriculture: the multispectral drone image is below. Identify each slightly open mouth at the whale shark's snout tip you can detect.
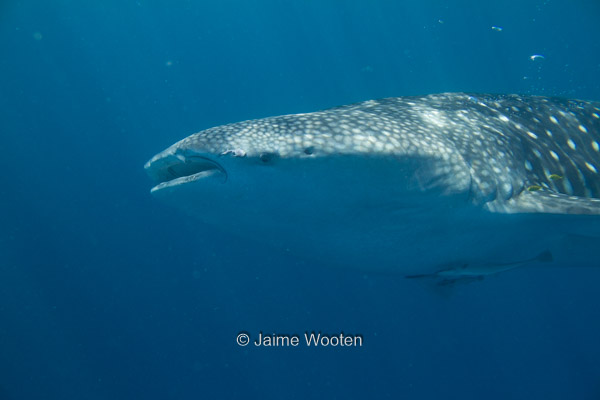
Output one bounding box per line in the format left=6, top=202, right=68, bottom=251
left=144, top=154, right=227, bottom=192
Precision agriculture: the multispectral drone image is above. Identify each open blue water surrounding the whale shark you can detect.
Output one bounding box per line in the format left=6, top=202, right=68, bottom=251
left=0, top=0, right=600, bottom=400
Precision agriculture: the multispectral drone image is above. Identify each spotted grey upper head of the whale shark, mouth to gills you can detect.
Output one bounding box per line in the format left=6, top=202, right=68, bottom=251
left=145, top=101, right=476, bottom=191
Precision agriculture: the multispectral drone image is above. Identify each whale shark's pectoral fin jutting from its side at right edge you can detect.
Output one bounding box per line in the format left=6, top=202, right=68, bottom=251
left=500, top=190, right=600, bottom=215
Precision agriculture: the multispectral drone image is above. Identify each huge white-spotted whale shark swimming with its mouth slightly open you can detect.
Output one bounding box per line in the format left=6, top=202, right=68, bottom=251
left=145, top=93, right=600, bottom=282
